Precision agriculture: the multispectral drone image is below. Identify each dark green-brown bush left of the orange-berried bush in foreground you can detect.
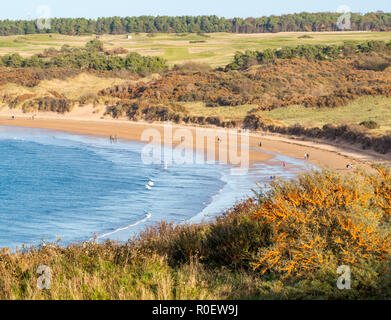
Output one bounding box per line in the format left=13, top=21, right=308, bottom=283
left=139, top=199, right=270, bottom=270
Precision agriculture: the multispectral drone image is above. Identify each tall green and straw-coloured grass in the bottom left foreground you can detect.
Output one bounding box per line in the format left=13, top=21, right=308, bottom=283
left=0, top=248, right=264, bottom=300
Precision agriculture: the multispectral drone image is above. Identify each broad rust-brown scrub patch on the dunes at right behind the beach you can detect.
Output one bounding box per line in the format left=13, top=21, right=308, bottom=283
left=99, top=45, right=391, bottom=111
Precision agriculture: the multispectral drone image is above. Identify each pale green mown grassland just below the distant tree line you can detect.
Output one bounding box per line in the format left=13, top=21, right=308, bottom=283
left=0, top=32, right=391, bottom=67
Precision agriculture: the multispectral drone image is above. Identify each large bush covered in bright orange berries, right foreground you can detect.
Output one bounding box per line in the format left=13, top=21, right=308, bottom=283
left=255, top=168, right=391, bottom=279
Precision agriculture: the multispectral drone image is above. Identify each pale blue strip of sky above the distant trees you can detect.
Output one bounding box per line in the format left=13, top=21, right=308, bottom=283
left=0, top=0, right=391, bottom=19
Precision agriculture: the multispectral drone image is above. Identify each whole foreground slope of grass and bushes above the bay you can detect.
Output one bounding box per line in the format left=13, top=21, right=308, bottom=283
left=0, top=169, right=391, bottom=299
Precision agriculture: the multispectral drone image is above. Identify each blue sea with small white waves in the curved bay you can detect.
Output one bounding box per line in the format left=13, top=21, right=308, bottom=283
left=0, top=126, right=312, bottom=250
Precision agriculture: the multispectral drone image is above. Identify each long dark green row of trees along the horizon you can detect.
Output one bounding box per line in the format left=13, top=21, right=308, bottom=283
left=0, top=12, right=391, bottom=36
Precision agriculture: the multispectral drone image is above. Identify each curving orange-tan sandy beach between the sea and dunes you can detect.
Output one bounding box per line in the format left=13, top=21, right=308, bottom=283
left=0, top=112, right=390, bottom=171
